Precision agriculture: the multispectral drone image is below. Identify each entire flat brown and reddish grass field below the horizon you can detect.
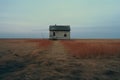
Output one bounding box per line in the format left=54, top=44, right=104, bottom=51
left=0, top=39, right=120, bottom=80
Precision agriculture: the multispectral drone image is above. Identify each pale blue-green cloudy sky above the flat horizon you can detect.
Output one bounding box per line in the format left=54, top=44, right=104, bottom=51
left=0, top=0, right=120, bottom=39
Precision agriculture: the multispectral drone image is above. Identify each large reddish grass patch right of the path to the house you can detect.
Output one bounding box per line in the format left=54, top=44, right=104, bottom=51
left=61, top=40, right=120, bottom=58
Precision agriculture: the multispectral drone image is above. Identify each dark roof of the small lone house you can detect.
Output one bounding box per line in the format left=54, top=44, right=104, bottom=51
left=49, top=25, right=70, bottom=31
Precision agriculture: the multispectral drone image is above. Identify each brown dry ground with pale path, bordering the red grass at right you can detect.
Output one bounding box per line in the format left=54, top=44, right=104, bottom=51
left=0, top=39, right=120, bottom=80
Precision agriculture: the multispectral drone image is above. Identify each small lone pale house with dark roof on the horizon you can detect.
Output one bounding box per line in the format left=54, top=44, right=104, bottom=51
left=49, top=25, right=70, bottom=39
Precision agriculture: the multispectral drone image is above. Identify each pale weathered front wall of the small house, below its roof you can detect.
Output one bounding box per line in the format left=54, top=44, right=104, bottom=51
left=49, top=31, right=70, bottom=39
